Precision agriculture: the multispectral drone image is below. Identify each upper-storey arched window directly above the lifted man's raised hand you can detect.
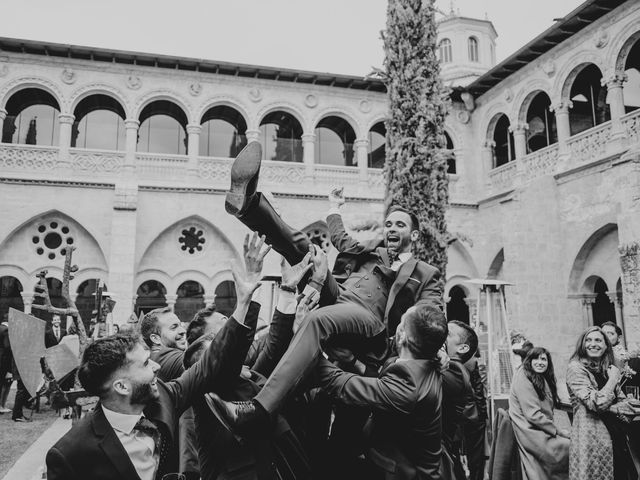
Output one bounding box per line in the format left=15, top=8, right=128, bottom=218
left=315, top=116, right=356, bottom=167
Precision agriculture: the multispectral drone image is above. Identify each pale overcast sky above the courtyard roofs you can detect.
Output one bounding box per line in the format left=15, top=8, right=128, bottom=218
left=0, top=0, right=583, bottom=76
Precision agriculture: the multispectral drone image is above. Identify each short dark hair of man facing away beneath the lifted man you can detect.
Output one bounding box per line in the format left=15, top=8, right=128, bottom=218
left=404, top=305, right=448, bottom=360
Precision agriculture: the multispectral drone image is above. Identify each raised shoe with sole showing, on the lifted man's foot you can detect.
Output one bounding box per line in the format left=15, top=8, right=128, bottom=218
left=224, top=142, right=262, bottom=217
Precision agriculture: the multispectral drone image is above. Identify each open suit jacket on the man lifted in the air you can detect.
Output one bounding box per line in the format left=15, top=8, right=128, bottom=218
left=327, top=214, right=442, bottom=335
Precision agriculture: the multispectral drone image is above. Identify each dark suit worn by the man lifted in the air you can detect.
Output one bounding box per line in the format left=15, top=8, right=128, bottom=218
left=239, top=193, right=442, bottom=413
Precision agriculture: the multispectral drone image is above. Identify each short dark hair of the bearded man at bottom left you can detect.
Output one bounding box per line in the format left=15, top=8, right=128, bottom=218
left=78, top=332, right=142, bottom=396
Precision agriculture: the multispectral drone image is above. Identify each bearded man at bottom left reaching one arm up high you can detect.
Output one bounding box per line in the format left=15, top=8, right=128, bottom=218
left=47, top=237, right=269, bottom=480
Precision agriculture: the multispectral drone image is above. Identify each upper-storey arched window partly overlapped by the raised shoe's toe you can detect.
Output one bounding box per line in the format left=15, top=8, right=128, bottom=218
left=199, top=105, right=247, bottom=158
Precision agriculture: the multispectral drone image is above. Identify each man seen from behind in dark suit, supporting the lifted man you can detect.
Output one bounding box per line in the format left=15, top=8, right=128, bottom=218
left=318, top=305, right=447, bottom=480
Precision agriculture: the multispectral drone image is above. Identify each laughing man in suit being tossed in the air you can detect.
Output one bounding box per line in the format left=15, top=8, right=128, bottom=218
left=208, top=142, right=442, bottom=429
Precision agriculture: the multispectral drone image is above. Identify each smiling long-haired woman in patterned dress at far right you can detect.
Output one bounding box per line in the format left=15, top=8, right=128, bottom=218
left=567, top=326, right=640, bottom=480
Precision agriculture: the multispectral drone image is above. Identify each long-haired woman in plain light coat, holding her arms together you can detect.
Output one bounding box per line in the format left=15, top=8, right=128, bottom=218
left=509, top=347, right=570, bottom=480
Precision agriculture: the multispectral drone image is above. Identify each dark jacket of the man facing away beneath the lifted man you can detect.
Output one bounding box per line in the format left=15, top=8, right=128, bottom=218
left=318, top=358, right=442, bottom=480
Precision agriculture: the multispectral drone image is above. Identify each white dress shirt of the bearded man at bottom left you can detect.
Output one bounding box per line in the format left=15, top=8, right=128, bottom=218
left=102, top=405, right=159, bottom=480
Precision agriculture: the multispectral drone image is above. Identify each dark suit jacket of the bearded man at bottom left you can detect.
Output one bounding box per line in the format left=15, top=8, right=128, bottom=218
left=46, top=314, right=255, bottom=480
